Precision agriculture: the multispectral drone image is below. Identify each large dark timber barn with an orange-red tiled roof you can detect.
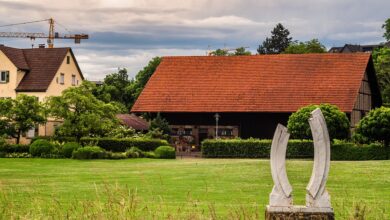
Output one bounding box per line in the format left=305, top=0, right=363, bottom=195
left=131, top=53, right=382, bottom=145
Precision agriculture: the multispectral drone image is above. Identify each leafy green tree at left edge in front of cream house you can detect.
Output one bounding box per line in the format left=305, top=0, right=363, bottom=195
left=0, top=94, right=46, bottom=144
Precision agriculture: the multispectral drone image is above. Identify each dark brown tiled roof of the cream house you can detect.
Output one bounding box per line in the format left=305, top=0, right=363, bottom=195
left=0, top=46, right=83, bottom=92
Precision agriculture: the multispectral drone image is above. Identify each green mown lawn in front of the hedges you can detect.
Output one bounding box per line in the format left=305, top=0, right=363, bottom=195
left=0, top=159, right=390, bottom=219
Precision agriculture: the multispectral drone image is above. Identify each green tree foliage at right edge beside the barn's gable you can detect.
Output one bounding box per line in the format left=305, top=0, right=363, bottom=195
left=372, top=47, right=390, bottom=106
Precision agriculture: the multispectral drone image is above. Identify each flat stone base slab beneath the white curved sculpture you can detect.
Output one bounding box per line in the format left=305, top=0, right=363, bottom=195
left=265, top=206, right=334, bottom=220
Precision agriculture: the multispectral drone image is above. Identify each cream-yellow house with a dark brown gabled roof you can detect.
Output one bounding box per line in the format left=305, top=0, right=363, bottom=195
left=0, top=45, right=84, bottom=141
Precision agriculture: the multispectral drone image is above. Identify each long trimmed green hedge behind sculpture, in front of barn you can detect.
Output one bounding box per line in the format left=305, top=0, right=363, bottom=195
left=202, top=139, right=390, bottom=160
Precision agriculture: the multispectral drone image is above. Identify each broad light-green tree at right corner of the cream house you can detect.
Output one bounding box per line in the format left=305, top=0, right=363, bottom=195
left=47, top=81, right=119, bottom=142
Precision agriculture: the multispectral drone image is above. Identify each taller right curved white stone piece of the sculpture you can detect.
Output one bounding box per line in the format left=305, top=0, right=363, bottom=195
left=306, top=108, right=331, bottom=208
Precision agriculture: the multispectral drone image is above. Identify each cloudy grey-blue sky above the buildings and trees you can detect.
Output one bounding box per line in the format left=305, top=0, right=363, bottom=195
left=0, top=0, right=390, bottom=80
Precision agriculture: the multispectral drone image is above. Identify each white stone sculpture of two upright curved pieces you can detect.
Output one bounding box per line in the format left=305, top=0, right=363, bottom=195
left=268, top=108, right=333, bottom=212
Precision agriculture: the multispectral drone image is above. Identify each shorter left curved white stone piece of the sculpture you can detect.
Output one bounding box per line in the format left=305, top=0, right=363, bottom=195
left=269, top=124, right=292, bottom=206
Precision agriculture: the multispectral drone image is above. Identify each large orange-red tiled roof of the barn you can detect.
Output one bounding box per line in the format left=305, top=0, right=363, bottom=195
left=131, top=53, right=375, bottom=112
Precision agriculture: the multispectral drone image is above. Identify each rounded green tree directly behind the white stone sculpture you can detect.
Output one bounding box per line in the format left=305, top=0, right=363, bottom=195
left=287, top=104, right=350, bottom=139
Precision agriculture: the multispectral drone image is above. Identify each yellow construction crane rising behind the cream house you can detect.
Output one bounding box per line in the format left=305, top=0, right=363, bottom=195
left=0, top=18, right=89, bottom=48
